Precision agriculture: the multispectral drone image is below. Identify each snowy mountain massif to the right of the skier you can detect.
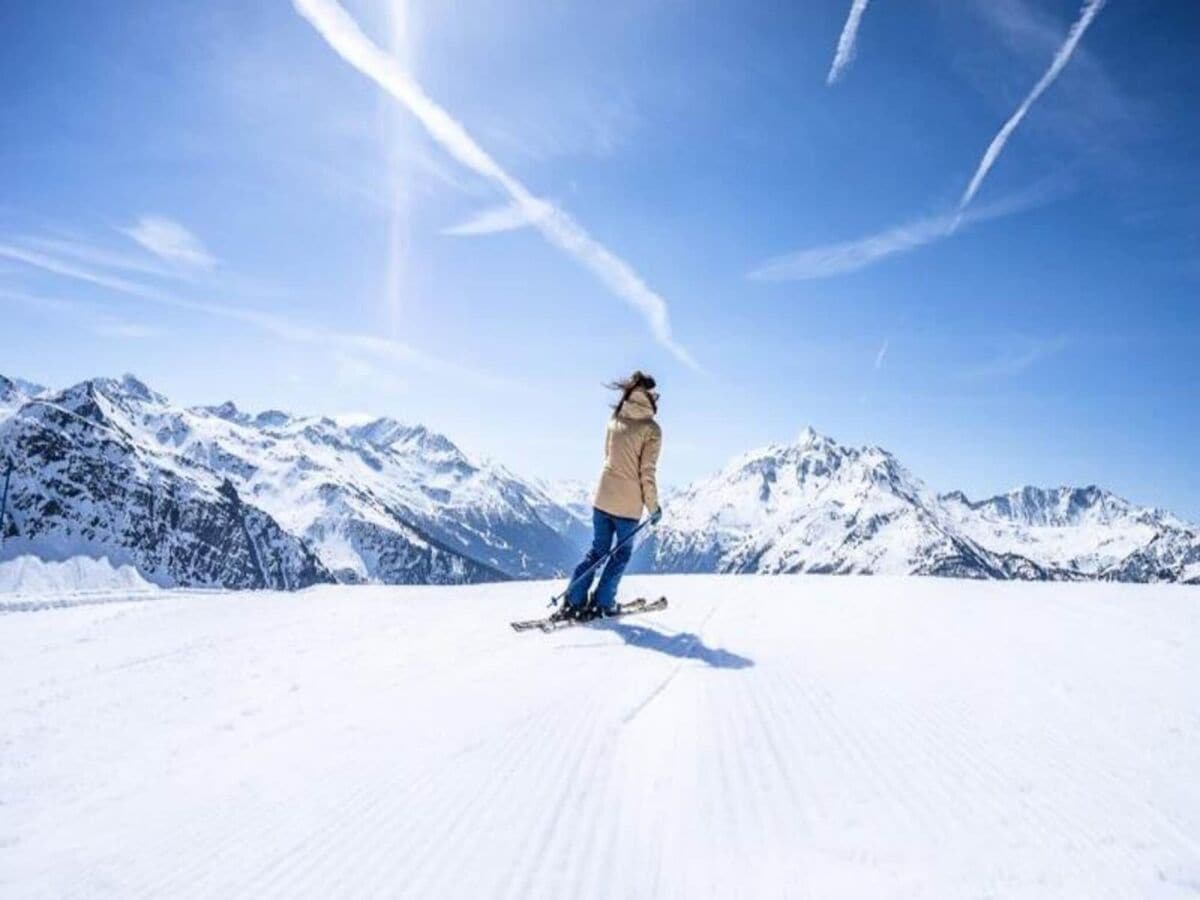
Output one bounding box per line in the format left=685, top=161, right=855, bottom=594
left=635, top=428, right=1200, bottom=581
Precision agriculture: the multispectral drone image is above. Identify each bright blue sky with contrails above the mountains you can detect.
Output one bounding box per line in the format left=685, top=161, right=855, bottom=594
left=0, top=0, right=1200, bottom=520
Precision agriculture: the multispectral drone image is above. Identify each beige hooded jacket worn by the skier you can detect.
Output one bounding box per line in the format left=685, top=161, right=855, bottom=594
left=593, top=390, right=662, bottom=518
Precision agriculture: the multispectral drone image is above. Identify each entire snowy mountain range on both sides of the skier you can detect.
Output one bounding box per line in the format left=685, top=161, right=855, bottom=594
left=0, top=376, right=1200, bottom=589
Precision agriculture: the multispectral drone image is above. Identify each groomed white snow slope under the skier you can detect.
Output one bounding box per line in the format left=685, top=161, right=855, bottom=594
left=0, top=576, right=1200, bottom=898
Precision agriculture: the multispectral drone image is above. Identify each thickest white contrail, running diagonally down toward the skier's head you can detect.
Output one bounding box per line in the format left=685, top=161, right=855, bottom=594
left=292, top=0, right=698, bottom=368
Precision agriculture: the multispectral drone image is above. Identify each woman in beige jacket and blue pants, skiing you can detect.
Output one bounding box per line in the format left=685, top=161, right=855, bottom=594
left=559, top=372, right=662, bottom=618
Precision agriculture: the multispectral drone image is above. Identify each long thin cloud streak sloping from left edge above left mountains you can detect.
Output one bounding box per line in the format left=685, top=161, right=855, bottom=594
left=0, top=244, right=510, bottom=389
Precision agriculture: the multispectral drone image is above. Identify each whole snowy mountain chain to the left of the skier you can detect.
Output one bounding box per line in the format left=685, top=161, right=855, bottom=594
left=0, top=376, right=578, bottom=588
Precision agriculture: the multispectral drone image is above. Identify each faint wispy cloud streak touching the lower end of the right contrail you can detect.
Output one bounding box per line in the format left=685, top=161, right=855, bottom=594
left=749, top=187, right=1048, bottom=281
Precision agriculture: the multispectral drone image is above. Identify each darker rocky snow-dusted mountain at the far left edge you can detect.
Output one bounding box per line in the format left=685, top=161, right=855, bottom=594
left=0, top=379, right=330, bottom=589
